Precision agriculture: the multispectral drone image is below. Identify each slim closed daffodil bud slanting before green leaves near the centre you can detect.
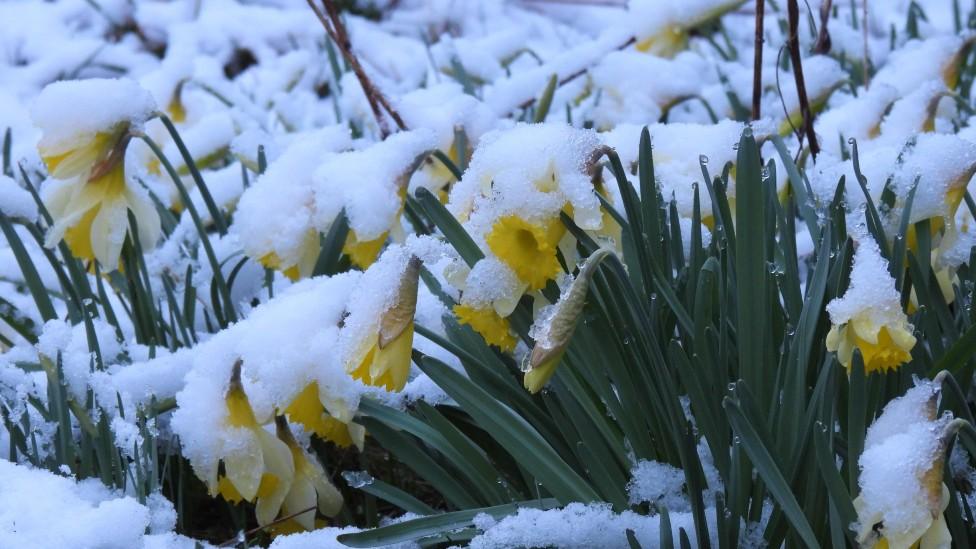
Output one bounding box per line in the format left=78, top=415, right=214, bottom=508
left=523, top=248, right=612, bottom=393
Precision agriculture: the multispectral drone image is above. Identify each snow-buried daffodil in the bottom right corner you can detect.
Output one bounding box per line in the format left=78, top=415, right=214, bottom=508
left=853, top=381, right=963, bottom=549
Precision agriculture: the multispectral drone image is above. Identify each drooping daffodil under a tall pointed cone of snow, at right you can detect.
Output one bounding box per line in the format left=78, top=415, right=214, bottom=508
left=826, top=238, right=916, bottom=373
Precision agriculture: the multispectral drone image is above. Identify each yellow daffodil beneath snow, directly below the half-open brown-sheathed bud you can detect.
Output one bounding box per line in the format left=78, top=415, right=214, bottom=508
left=285, top=382, right=366, bottom=450
